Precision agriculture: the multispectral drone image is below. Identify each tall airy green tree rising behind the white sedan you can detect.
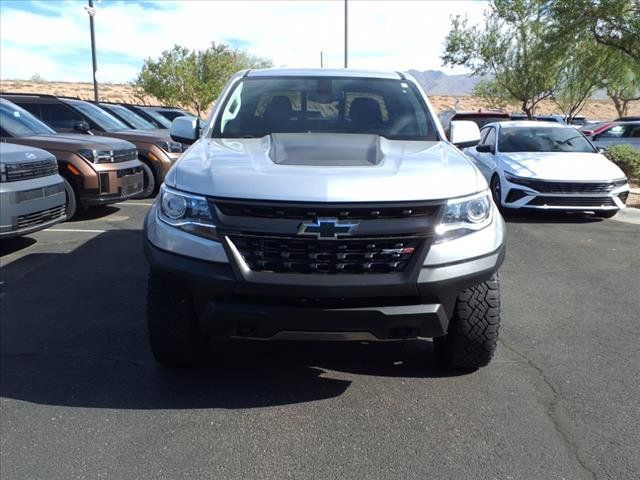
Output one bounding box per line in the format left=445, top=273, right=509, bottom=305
left=442, top=0, right=561, bottom=118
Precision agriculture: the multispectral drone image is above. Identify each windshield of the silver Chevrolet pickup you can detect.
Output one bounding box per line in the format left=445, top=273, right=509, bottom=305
left=213, top=77, right=438, bottom=140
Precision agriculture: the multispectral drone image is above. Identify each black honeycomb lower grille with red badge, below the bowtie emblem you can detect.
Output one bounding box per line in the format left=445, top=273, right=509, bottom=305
left=228, top=234, right=424, bottom=274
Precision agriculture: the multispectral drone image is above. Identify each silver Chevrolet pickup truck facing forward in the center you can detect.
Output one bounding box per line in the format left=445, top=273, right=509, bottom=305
left=145, top=69, right=505, bottom=369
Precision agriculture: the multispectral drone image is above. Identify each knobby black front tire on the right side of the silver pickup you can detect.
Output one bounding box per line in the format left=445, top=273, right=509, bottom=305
left=434, top=275, right=500, bottom=370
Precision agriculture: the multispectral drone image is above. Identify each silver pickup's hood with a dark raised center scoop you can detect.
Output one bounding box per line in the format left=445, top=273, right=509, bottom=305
left=165, top=133, right=487, bottom=202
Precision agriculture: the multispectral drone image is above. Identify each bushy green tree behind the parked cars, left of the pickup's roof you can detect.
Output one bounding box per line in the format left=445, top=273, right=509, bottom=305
left=134, top=43, right=271, bottom=116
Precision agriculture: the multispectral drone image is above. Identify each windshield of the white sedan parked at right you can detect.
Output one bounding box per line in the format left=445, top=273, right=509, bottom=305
left=498, top=127, right=595, bottom=153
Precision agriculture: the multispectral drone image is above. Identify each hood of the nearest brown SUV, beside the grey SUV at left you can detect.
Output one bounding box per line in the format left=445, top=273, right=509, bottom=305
left=9, top=133, right=136, bottom=152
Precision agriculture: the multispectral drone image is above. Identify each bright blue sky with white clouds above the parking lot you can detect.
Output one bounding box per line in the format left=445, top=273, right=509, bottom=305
left=0, top=0, right=486, bottom=82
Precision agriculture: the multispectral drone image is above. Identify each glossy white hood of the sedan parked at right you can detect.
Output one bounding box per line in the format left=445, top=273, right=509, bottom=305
left=499, top=152, right=624, bottom=181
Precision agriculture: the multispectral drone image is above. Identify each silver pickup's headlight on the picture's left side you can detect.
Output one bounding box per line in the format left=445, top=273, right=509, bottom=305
left=158, top=185, right=218, bottom=240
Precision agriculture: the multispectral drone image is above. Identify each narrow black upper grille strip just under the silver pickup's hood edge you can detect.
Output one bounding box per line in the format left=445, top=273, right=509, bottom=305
left=215, top=200, right=440, bottom=220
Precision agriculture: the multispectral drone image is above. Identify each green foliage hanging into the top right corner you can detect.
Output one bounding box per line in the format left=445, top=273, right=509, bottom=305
left=548, top=0, right=640, bottom=61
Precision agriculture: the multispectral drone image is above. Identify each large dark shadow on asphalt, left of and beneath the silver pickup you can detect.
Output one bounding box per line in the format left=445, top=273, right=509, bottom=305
left=0, top=230, right=460, bottom=409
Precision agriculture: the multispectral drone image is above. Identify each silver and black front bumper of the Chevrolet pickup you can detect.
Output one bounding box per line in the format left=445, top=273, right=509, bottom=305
left=144, top=207, right=505, bottom=340
